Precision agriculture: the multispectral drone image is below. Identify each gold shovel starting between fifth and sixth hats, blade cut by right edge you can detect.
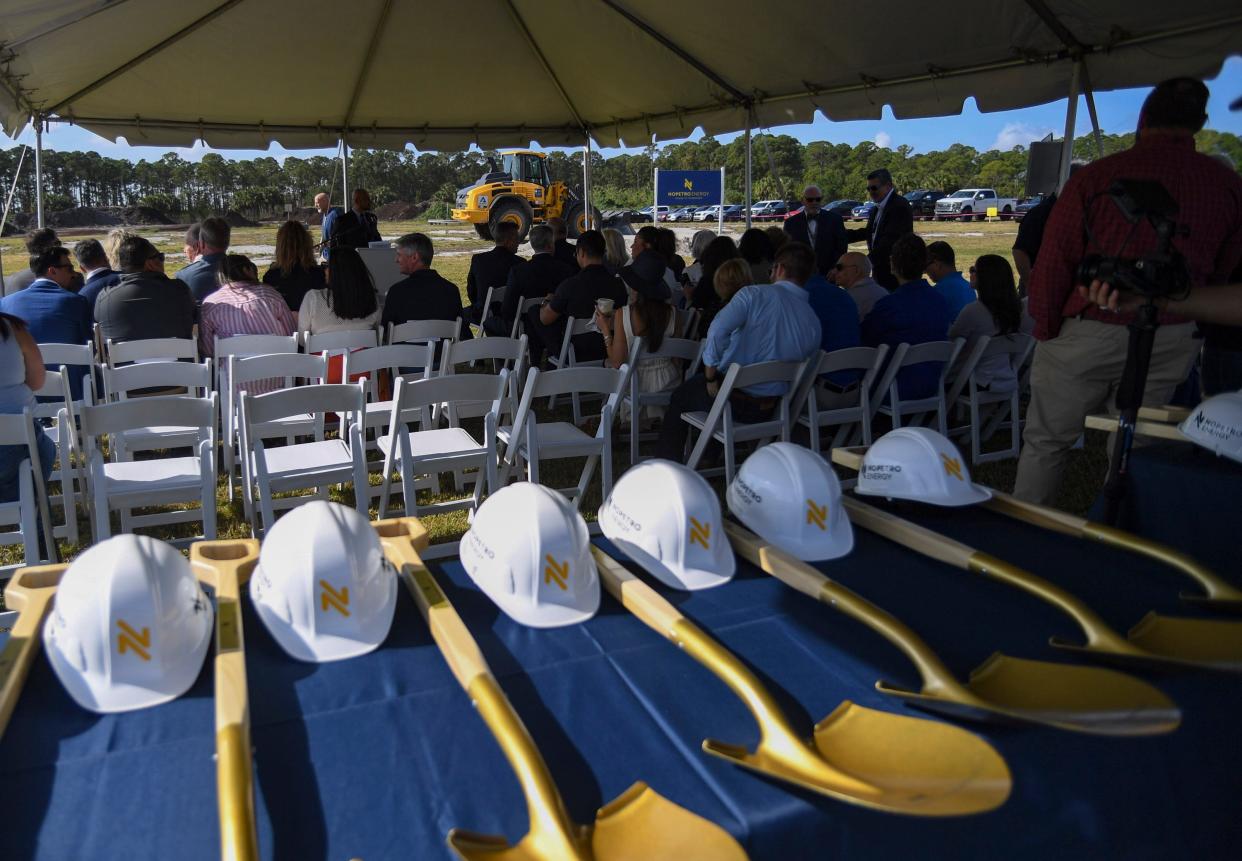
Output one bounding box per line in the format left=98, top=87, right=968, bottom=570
left=841, top=497, right=1242, bottom=672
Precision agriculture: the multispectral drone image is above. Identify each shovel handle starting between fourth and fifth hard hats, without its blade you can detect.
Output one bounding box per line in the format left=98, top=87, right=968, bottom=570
left=724, top=521, right=961, bottom=692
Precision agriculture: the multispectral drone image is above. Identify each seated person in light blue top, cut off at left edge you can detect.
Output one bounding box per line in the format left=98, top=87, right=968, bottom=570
left=0, top=313, right=56, bottom=502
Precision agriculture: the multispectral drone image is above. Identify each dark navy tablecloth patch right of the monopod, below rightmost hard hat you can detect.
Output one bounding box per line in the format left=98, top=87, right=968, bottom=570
left=1090, top=442, right=1242, bottom=580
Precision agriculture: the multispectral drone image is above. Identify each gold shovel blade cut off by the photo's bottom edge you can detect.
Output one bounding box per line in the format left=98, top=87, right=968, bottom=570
left=448, top=781, right=746, bottom=861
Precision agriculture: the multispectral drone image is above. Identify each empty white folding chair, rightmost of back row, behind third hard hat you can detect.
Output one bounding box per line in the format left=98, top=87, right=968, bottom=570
left=497, top=365, right=630, bottom=506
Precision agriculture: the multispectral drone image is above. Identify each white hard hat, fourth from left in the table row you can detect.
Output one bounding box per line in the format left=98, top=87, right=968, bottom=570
left=600, top=460, right=737, bottom=589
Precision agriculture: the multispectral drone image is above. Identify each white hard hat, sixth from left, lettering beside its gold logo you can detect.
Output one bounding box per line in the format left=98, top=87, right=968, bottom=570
left=854, top=427, right=992, bottom=506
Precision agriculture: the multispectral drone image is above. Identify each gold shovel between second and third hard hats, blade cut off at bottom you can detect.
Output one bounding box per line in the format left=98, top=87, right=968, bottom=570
left=375, top=517, right=746, bottom=861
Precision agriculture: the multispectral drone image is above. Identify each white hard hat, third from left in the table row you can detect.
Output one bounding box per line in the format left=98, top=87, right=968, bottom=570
left=460, top=482, right=600, bottom=627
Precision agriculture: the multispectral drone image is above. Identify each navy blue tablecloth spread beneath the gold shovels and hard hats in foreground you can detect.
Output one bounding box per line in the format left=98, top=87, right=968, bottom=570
left=0, top=508, right=1242, bottom=861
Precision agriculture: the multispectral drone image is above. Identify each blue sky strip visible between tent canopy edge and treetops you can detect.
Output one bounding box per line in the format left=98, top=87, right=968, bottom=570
left=0, top=57, right=1242, bottom=162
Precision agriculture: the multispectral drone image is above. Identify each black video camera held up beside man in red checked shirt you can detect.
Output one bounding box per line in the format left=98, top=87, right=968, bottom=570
left=1077, top=179, right=1190, bottom=299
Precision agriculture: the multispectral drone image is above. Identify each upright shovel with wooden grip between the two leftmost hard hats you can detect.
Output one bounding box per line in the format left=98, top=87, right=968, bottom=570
left=190, top=538, right=258, bottom=861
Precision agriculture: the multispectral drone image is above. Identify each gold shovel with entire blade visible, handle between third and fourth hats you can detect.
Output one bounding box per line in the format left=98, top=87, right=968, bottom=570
left=591, top=547, right=1012, bottom=816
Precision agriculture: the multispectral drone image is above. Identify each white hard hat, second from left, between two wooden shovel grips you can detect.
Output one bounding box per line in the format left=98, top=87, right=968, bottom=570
left=250, top=499, right=396, bottom=663
